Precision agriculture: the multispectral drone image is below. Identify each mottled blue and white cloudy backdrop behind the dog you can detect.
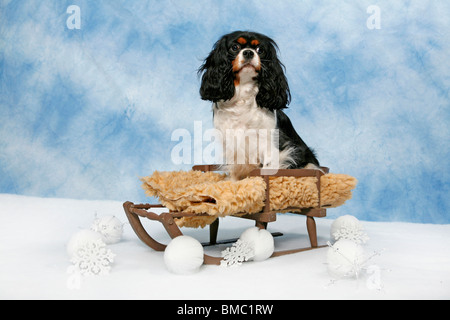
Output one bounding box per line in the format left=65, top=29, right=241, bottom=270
left=0, top=0, right=450, bottom=223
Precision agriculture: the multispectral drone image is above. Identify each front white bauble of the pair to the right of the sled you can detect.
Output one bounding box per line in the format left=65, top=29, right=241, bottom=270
left=327, top=239, right=365, bottom=278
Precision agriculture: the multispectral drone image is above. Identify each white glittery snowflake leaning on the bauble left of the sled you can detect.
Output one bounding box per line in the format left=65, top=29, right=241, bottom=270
left=70, top=239, right=115, bottom=276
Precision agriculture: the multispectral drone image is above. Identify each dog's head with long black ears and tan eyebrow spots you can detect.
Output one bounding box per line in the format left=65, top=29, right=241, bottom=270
left=198, top=31, right=291, bottom=110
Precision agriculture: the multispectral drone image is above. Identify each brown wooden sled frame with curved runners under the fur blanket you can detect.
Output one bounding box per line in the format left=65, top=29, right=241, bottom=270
left=123, top=165, right=329, bottom=265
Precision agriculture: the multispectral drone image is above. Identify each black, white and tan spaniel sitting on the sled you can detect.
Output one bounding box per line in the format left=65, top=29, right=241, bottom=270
left=198, top=31, right=320, bottom=180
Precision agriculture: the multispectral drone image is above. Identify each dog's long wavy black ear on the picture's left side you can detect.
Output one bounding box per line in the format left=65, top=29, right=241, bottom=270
left=198, top=36, right=235, bottom=102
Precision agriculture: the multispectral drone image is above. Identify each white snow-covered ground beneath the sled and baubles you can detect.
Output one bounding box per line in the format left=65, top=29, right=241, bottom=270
left=0, top=194, right=450, bottom=300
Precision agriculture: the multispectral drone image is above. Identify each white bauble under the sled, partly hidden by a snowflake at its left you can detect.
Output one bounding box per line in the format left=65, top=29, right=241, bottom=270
left=239, top=227, right=275, bottom=261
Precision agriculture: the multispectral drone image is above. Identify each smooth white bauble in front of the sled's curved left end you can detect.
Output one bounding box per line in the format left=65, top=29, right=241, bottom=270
left=164, top=236, right=204, bottom=274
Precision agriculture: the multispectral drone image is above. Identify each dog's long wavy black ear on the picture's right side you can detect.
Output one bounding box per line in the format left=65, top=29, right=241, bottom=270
left=256, top=39, right=291, bottom=110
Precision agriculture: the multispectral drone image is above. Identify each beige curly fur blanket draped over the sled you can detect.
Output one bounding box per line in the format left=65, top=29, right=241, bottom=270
left=141, top=170, right=357, bottom=227
